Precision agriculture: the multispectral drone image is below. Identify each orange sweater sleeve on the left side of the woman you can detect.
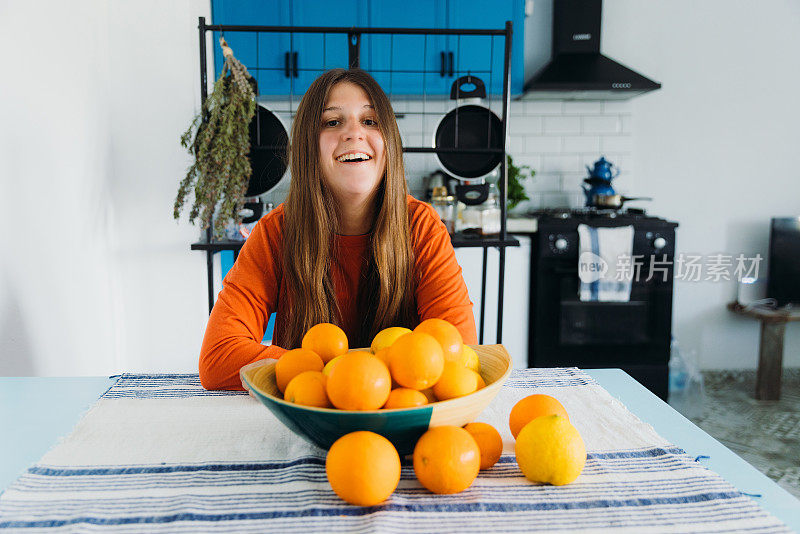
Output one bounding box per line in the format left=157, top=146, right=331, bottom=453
left=199, top=210, right=285, bottom=390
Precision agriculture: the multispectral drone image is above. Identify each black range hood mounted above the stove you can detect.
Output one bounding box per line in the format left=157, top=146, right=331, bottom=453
left=521, top=0, right=661, bottom=100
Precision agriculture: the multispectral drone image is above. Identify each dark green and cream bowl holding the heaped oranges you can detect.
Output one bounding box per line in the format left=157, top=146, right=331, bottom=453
left=239, top=345, right=511, bottom=456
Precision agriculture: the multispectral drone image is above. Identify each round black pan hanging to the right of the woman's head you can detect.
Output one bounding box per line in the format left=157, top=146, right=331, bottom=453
left=434, top=75, right=503, bottom=179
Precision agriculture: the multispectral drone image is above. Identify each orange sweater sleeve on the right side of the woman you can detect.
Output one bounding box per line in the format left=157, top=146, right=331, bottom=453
left=409, top=200, right=478, bottom=344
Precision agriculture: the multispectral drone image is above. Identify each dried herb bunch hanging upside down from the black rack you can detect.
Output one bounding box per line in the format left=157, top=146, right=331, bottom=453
left=173, top=38, right=256, bottom=238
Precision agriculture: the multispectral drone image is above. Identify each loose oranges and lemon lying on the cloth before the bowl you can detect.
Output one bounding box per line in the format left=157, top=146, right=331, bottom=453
left=325, top=394, right=586, bottom=506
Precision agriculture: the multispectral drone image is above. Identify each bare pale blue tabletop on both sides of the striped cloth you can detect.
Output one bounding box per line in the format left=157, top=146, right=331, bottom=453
left=0, top=369, right=800, bottom=532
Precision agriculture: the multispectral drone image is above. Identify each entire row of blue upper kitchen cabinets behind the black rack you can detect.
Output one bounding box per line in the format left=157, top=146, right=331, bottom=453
left=212, top=0, right=524, bottom=95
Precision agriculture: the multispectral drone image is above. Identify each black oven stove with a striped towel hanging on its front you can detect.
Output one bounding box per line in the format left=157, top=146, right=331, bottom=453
left=528, top=208, right=678, bottom=399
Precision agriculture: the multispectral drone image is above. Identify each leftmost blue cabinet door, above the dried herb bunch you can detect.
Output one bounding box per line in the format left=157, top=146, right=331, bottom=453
left=211, top=0, right=297, bottom=95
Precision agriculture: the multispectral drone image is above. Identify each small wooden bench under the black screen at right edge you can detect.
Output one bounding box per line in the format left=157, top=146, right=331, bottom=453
left=728, top=302, right=800, bottom=400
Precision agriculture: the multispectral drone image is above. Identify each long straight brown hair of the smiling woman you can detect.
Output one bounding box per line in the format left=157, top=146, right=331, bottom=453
left=276, top=69, right=418, bottom=348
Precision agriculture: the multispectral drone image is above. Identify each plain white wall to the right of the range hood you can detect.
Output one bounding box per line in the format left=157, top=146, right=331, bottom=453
left=603, top=0, right=800, bottom=368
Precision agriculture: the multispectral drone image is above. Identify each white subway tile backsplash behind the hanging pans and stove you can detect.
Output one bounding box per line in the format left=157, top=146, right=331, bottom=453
left=264, top=100, right=635, bottom=212
